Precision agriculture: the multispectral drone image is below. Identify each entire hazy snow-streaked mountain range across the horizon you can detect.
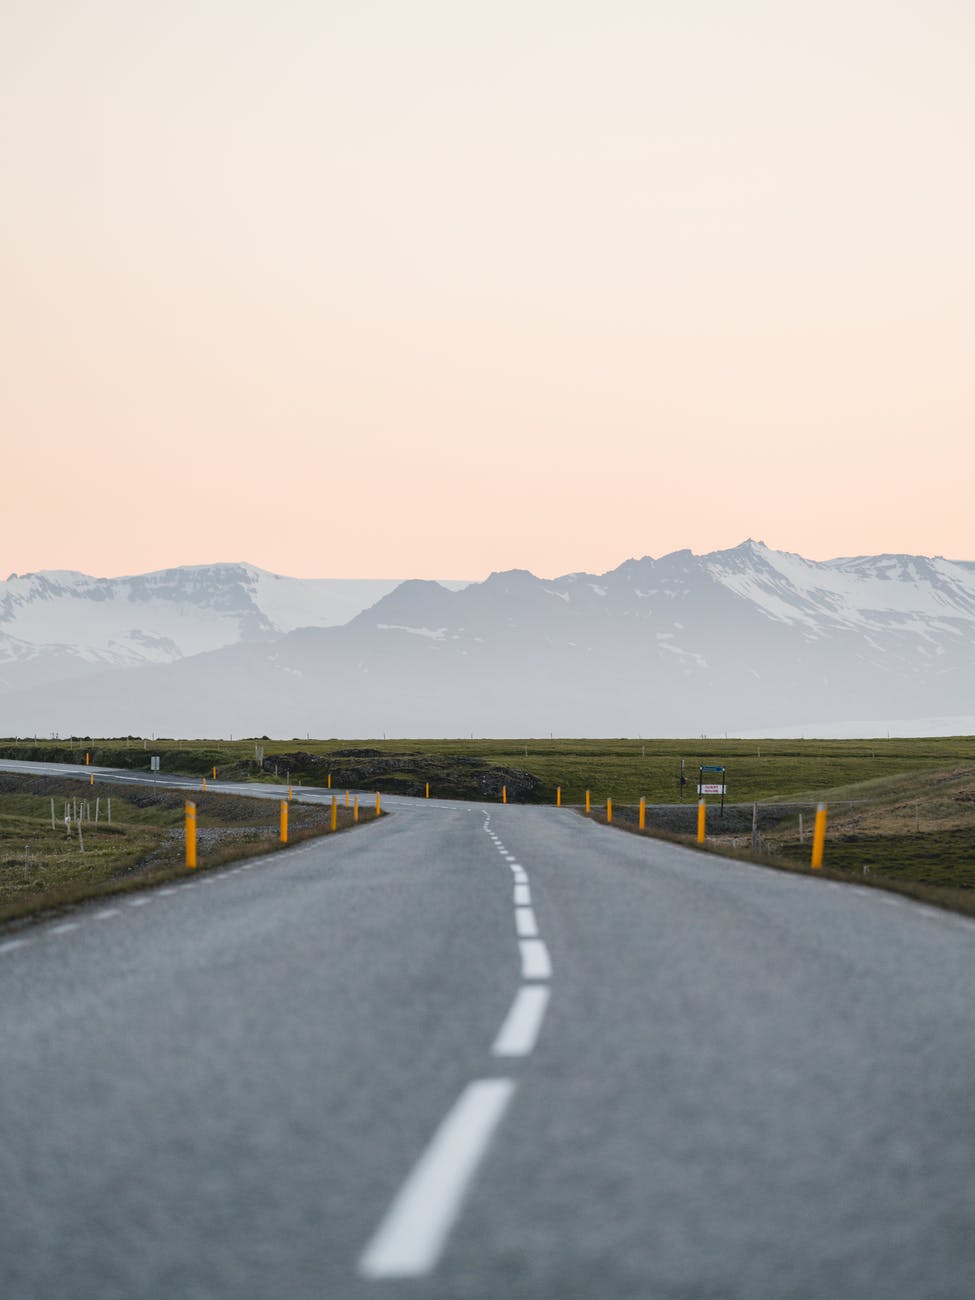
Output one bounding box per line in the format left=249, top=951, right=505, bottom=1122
left=0, top=541, right=975, bottom=737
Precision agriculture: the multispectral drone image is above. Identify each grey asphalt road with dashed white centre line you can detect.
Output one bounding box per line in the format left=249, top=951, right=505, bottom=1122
left=0, top=763, right=975, bottom=1300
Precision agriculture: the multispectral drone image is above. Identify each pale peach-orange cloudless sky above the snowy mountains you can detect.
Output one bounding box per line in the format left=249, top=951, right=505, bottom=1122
left=0, top=0, right=975, bottom=579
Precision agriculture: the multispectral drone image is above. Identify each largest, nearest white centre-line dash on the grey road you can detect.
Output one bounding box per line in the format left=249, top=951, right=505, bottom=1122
left=359, top=1079, right=515, bottom=1278
